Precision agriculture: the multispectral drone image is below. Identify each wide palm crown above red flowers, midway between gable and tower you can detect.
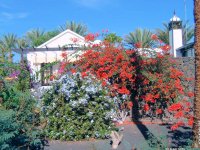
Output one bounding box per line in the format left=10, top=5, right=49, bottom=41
left=125, top=29, right=153, bottom=48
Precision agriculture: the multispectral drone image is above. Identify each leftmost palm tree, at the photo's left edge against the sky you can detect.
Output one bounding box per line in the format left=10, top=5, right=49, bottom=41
left=1, top=33, right=17, bottom=62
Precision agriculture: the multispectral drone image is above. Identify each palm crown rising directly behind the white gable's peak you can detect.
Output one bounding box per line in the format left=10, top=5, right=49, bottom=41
left=59, top=21, right=88, bottom=36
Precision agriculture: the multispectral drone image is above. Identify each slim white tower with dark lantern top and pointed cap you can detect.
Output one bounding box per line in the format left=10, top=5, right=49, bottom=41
left=169, top=12, right=183, bottom=57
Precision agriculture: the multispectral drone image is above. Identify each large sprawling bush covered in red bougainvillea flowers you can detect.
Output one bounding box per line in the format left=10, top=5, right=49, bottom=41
left=55, top=34, right=194, bottom=130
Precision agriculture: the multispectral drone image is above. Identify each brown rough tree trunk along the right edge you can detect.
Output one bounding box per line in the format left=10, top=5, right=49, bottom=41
left=193, top=0, right=200, bottom=148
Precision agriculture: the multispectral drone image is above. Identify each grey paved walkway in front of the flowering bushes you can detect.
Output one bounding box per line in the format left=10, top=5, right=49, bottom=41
left=45, top=123, right=191, bottom=150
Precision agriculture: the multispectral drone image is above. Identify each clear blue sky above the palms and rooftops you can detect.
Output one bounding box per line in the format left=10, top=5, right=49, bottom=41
left=0, top=0, right=194, bottom=37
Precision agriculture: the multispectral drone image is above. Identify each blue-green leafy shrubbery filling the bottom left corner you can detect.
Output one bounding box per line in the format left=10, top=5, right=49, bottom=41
left=0, top=79, right=43, bottom=149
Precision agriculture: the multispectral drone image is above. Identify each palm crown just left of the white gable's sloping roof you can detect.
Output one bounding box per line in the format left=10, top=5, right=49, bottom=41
left=25, top=29, right=44, bottom=47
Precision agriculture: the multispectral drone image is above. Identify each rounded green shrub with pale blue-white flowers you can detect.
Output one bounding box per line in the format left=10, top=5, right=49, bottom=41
left=42, top=73, right=117, bottom=140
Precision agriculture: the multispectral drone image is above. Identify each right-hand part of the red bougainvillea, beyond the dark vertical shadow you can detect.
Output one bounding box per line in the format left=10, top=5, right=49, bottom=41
left=135, top=37, right=194, bottom=130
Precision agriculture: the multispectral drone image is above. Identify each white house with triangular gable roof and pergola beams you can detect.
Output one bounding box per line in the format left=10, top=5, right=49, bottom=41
left=14, top=29, right=96, bottom=85
